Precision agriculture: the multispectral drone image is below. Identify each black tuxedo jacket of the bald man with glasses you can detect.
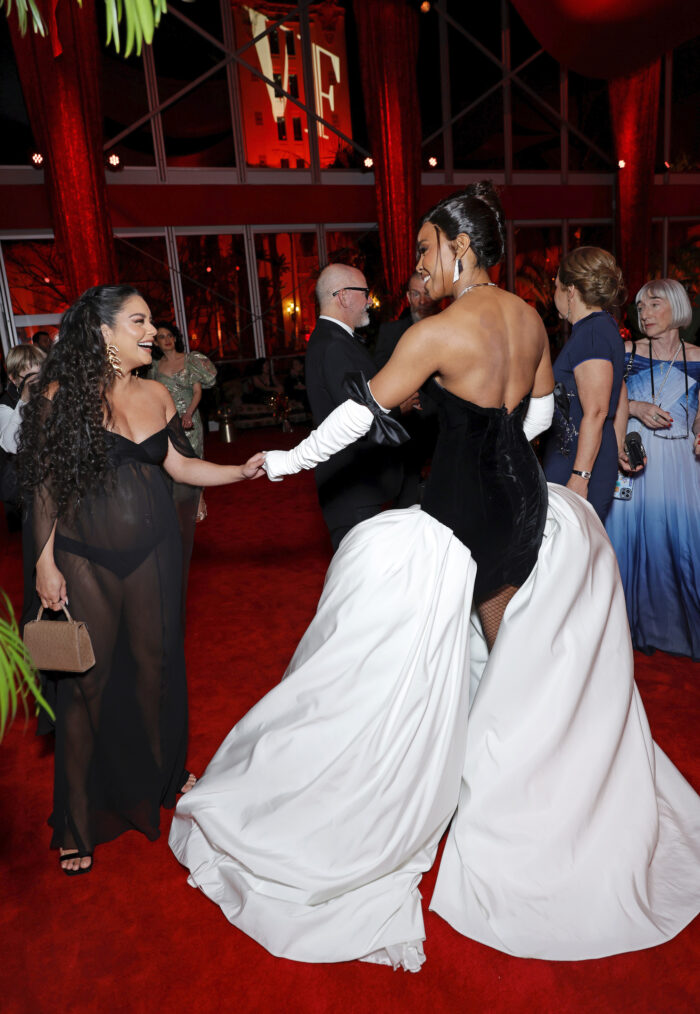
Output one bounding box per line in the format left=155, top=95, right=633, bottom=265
left=305, top=320, right=403, bottom=529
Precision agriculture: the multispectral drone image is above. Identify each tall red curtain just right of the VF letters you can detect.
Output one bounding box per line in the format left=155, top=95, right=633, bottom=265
left=354, top=0, right=421, bottom=304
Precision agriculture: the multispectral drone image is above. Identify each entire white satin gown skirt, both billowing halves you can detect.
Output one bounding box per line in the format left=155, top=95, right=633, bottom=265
left=170, top=486, right=700, bottom=970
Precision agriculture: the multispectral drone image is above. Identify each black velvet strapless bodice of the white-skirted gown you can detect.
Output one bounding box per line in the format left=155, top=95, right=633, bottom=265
left=422, top=380, right=547, bottom=602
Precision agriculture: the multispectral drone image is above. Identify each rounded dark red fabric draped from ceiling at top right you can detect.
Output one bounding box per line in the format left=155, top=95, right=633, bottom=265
left=512, top=0, right=698, bottom=78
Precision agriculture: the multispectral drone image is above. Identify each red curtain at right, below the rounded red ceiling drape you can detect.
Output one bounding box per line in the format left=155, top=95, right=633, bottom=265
left=609, top=59, right=661, bottom=298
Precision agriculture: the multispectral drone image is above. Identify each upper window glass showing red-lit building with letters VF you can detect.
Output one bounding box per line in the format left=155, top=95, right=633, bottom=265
left=233, top=3, right=359, bottom=168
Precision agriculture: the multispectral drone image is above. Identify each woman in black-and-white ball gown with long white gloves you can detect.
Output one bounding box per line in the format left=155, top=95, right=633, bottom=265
left=170, top=183, right=700, bottom=971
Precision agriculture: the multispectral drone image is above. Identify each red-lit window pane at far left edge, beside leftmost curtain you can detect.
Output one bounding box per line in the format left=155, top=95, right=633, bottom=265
left=2, top=239, right=69, bottom=316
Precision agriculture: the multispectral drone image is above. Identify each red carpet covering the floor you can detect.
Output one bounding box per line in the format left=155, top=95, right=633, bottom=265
left=0, top=430, right=700, bottom=1014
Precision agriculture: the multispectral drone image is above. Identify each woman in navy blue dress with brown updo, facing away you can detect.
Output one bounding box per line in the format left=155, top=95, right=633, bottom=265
left=544, top=246, right=625, bottom=520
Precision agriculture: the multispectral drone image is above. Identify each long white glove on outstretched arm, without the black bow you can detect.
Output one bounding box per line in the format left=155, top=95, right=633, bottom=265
left=263, top=399, right=374, bottom=483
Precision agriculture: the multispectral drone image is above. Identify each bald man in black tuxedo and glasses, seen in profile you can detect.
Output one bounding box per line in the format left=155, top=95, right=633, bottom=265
left=305, top=264, right=403, bottom=551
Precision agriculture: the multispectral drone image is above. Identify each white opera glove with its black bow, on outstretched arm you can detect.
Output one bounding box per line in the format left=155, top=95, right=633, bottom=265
left=263, top=373, right=408, bottom=483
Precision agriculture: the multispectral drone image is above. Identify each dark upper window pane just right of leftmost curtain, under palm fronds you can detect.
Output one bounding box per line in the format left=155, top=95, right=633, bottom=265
left=95, top=4, right=155, bottom=166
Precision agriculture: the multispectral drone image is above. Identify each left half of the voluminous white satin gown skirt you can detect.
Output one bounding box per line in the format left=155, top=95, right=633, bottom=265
left=169, top=508, right=476, bottom=970
